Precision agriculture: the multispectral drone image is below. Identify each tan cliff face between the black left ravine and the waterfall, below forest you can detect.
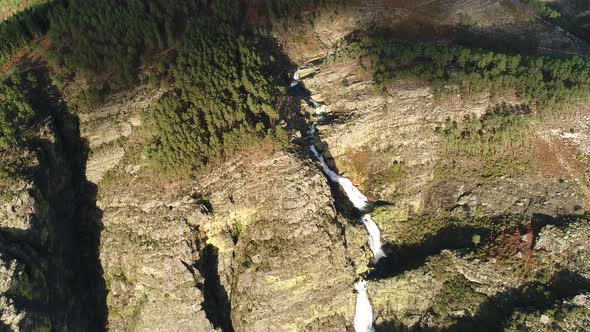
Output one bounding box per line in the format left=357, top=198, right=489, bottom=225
left=76, top=82, right=368, bottom=331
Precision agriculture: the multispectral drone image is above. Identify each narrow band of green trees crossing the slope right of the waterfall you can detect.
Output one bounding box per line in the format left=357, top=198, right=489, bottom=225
left=328, top=38, right=590, bottom=110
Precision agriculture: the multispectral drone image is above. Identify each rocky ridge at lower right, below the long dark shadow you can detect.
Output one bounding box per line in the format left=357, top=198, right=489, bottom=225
left=369, top=219, right=590, bottom=331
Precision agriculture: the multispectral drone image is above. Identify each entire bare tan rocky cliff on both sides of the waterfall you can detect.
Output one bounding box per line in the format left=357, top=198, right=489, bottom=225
left=0, top=0, right=590, bottom=331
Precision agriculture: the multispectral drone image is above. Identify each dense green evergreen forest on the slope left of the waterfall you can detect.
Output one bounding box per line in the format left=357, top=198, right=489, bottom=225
left=0, top=0, right=312, bottom=176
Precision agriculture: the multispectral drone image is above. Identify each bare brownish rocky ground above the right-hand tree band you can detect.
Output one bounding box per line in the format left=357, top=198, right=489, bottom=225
left=273, top=0, right=588, bottom=64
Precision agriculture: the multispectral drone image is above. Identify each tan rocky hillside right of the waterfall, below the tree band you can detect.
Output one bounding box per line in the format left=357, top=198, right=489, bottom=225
left=302, top=26, right=589, bottom=331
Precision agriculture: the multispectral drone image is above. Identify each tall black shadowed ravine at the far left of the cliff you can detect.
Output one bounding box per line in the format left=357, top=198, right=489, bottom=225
left=36, top=68, right=108, bottom=331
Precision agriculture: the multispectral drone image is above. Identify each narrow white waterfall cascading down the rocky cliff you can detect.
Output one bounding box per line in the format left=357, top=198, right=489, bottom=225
left=290, top=70, right=385, bottom=332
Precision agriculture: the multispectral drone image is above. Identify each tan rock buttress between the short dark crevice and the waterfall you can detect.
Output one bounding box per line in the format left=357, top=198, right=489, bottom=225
left=194, top=152, right=362, bottom=331
